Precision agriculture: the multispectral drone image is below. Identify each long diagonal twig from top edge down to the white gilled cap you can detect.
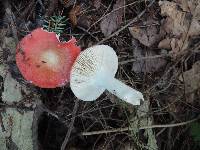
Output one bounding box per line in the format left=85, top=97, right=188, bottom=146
left=96, top=0, right=155, bottom=45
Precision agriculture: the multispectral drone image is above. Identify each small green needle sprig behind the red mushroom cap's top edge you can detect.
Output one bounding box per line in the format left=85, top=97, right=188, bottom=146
left=43, top=15, right=67, bottom=35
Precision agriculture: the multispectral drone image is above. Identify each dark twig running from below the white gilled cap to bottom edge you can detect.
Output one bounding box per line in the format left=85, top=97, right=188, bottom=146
left=61, top=99, right=78, bottom=150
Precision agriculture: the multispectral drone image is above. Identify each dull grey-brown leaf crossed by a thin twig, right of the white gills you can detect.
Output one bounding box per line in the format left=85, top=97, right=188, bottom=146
left=132, top=39, right=167, bottom=73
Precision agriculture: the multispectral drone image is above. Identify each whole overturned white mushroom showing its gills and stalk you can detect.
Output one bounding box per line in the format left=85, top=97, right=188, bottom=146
left=70, top=45, right=144, bottom=105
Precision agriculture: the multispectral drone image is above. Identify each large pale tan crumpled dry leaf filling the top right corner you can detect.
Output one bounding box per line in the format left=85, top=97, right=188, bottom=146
left=159, top=0, right=200, bottom=58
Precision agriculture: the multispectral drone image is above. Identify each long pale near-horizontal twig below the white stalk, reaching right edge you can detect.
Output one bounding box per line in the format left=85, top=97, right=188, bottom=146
left=81, top=115, right=200, bottom=136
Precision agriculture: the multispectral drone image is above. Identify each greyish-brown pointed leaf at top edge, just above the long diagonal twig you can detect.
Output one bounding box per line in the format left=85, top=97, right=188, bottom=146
left=100, top=0, right=124, bottom=37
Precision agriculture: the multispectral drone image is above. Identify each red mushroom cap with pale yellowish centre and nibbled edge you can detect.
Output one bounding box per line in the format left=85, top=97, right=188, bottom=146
left=16, top=28, right=80, bottom=88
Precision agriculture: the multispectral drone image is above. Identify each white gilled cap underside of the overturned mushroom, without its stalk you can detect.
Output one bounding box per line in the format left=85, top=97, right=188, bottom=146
left=70, top=45, right=118, bottom=101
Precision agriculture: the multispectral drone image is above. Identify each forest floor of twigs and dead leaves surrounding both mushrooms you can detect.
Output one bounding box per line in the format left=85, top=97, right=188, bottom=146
left=0, top=0, right=200, bottom=150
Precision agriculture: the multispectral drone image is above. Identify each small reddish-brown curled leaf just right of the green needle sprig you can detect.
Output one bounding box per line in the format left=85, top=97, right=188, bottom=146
left=69, top=5, right=81, bottom=27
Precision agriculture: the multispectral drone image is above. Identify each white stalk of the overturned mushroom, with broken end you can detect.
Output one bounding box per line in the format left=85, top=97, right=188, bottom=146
left=101, top=77, right=144, bottom=105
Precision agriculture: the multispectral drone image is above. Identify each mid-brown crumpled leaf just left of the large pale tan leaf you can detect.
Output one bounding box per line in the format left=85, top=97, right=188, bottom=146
left=129, top=19, right=163, bottom=47
